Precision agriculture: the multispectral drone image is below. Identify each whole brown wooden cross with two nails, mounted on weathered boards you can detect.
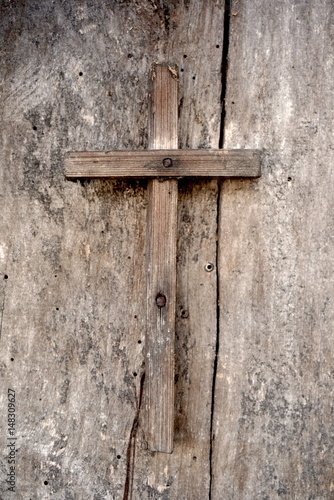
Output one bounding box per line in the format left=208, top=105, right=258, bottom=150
left=65, top=64, right=260, bottom=453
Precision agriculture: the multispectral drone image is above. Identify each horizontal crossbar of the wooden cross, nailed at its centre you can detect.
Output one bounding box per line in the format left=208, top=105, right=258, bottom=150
left=65, top=149, right=261, bottom=179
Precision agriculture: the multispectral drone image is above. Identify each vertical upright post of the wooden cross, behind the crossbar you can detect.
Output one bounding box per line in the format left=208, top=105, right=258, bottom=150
left=146, top=65, right=178, bottom=453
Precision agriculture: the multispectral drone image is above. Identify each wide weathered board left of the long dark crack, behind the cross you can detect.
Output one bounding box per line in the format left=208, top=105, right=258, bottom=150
left=0, top=0, right=224, bottom=500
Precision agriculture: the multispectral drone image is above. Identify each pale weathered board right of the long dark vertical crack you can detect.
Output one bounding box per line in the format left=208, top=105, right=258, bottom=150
left=212, top=0, right=334, bottom=500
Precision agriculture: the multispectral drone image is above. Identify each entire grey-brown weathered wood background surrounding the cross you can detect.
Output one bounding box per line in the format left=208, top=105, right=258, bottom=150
left=0, top=0, right=334, bottom=500
